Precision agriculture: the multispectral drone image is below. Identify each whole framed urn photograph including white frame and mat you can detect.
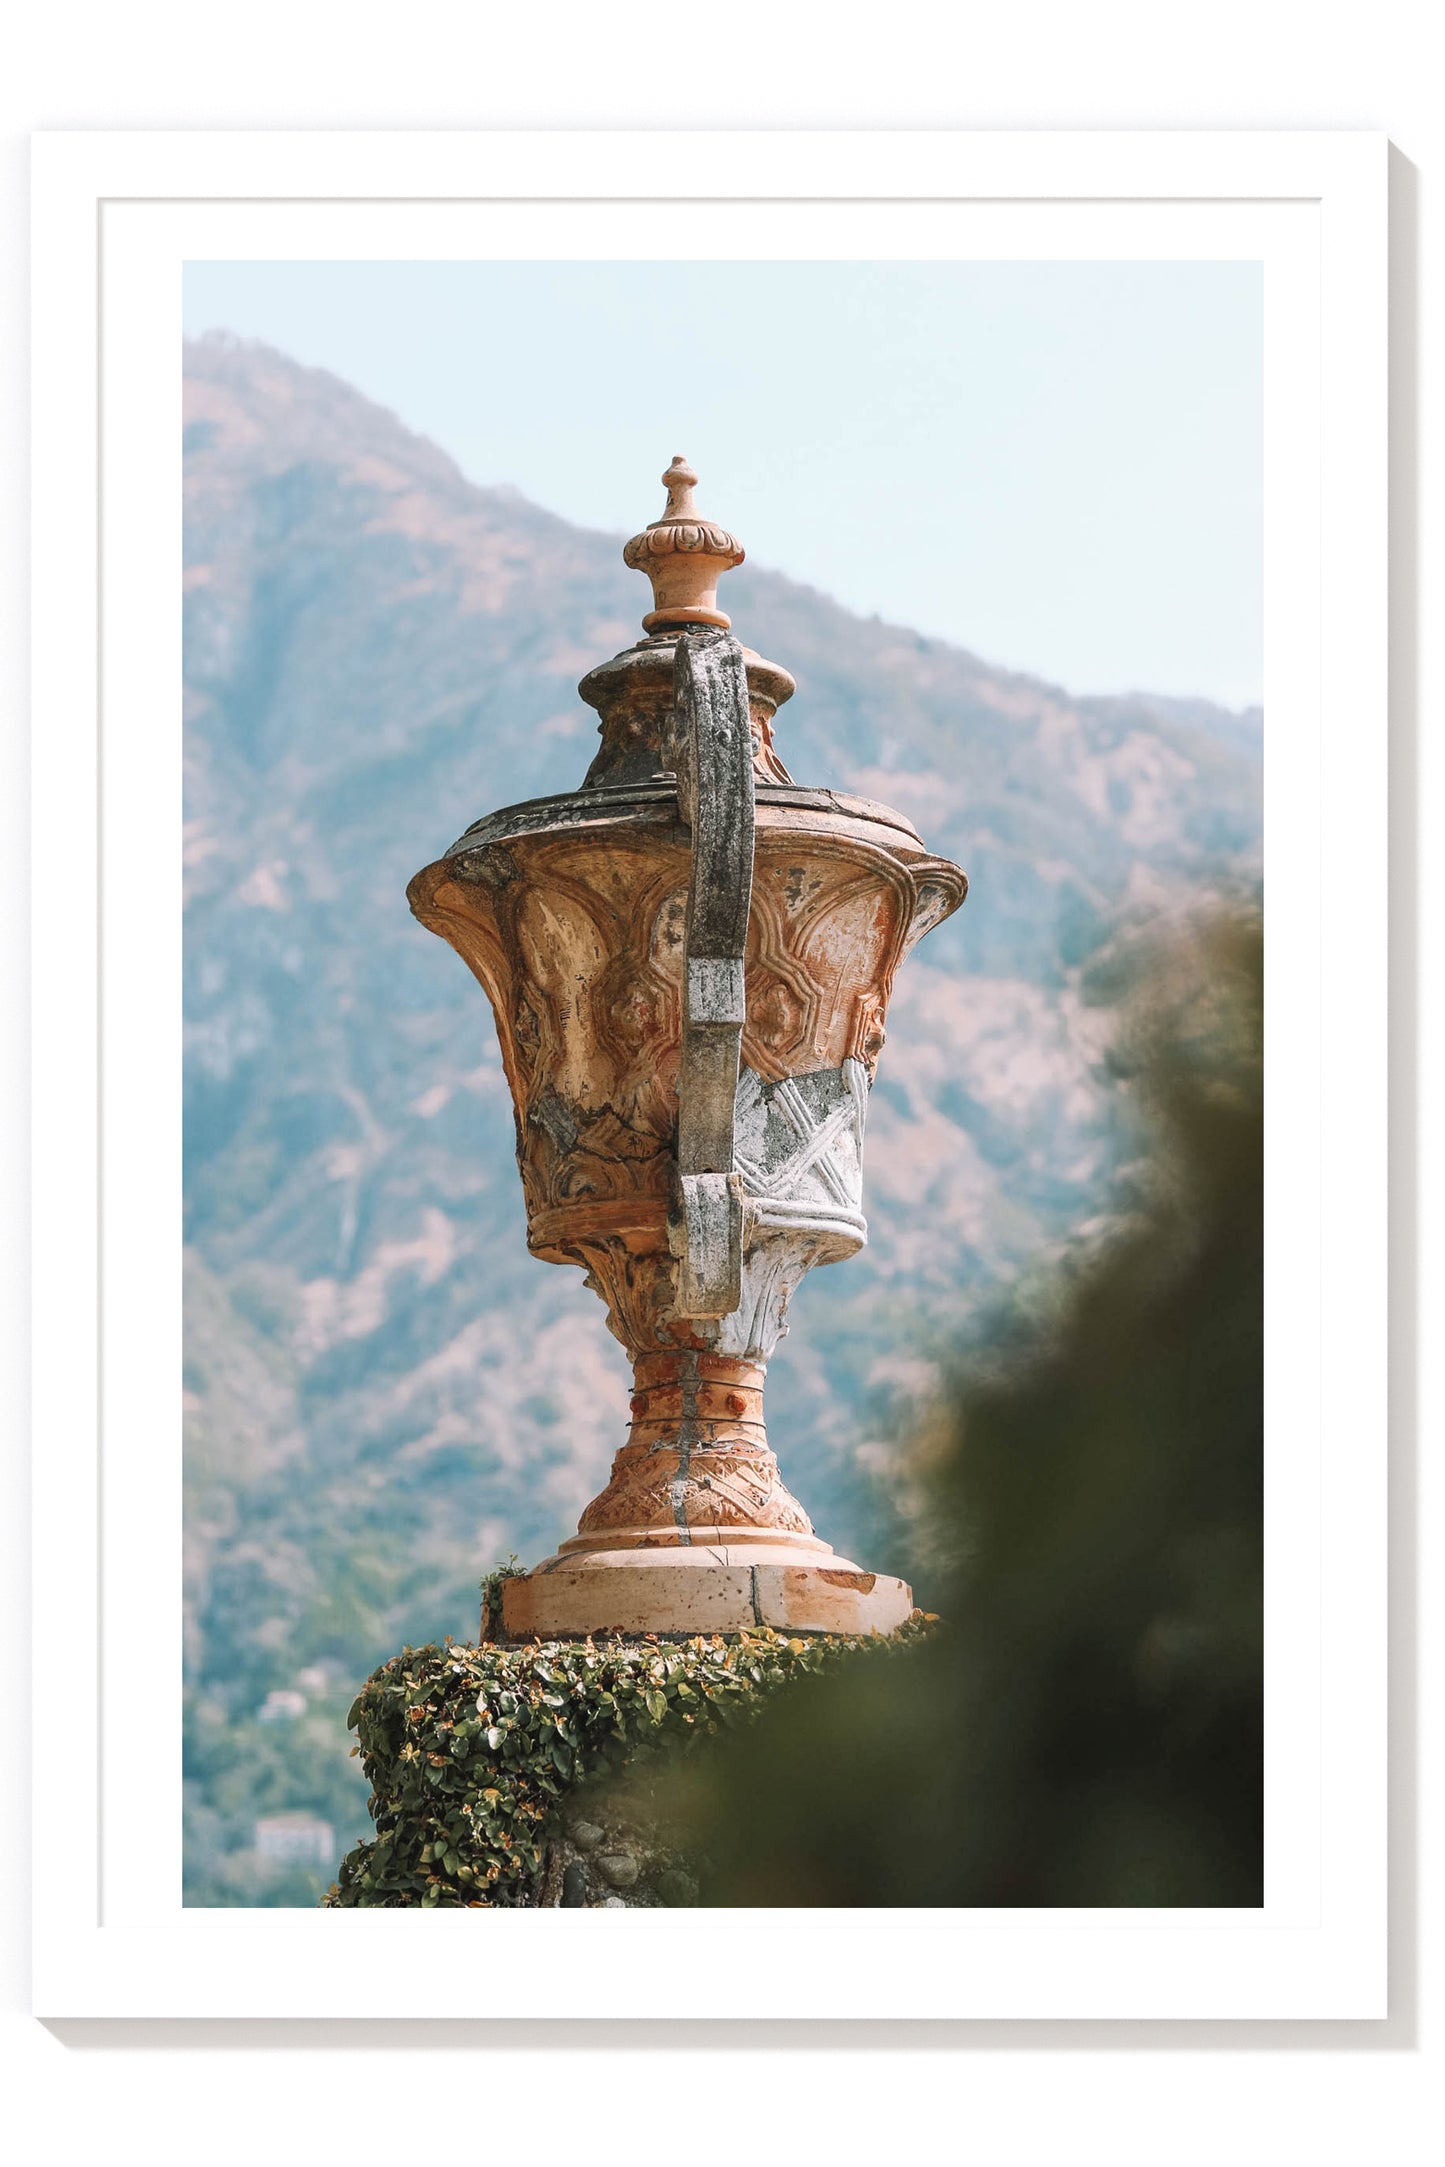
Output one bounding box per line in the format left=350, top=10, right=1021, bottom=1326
left=35, top=132, right=1387, bottom=2020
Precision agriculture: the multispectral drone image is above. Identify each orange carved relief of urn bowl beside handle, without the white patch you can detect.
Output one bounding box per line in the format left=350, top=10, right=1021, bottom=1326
left=412, top=821, right=958, bottom=1255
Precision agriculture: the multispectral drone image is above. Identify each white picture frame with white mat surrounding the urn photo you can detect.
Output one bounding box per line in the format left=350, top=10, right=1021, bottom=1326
left=32, top=132, right=1387, bottom=2020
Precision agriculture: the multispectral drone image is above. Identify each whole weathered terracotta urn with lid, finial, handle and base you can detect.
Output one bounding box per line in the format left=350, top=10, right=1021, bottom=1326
left=407, top=459, right=966, bottom=1638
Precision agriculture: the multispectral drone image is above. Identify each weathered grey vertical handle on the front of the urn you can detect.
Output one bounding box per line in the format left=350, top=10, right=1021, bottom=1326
left=669, top=628, right=754, bottom=1318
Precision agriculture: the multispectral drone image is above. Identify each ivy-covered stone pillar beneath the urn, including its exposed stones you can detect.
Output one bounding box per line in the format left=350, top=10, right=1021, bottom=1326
left=325, top=1614, right=927, bottom=1909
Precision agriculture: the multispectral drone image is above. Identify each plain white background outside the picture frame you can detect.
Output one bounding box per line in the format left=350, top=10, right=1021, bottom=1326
left=0, top=0, right=1445, bottom=2167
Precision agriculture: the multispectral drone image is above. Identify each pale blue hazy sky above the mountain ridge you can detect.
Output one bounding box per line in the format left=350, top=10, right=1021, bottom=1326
left=184, top=262, right=1263, bottom=706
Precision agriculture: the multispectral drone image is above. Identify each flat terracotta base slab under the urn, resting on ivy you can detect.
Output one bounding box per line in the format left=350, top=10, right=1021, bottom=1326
left=500, top=1545, right=914, bottom=1640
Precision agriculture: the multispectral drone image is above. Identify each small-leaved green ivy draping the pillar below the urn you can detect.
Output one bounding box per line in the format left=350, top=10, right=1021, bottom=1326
left=323, top=1612, right=932, bottom=1909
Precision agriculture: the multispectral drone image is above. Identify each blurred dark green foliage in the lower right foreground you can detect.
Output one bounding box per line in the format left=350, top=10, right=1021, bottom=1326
left=674, top=914, right=1263, bottom=1907
